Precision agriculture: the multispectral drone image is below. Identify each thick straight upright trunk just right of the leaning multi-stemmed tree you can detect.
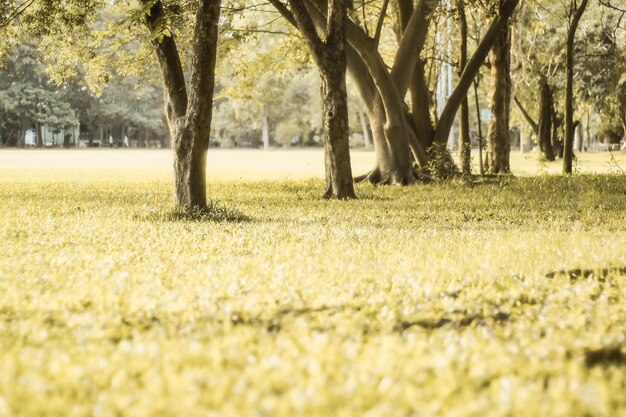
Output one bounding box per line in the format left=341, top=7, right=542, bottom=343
left=486, top=0, right=511, bottom=174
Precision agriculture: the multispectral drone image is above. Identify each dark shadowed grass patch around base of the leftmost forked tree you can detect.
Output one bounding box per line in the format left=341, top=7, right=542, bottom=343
left=133, top=201, right=253, bottom=223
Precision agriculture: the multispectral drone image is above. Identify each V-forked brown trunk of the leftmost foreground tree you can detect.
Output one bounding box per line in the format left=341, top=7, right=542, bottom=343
left=146, top=0, right=220, bottom=211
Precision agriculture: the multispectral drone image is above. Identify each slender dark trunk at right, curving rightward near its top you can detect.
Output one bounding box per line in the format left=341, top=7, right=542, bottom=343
left=563, top=0, right=588, bottom=174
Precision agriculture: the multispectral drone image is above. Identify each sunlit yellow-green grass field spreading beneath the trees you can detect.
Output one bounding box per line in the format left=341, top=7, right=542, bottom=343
left=0, top=150, right=626, bottom=417
